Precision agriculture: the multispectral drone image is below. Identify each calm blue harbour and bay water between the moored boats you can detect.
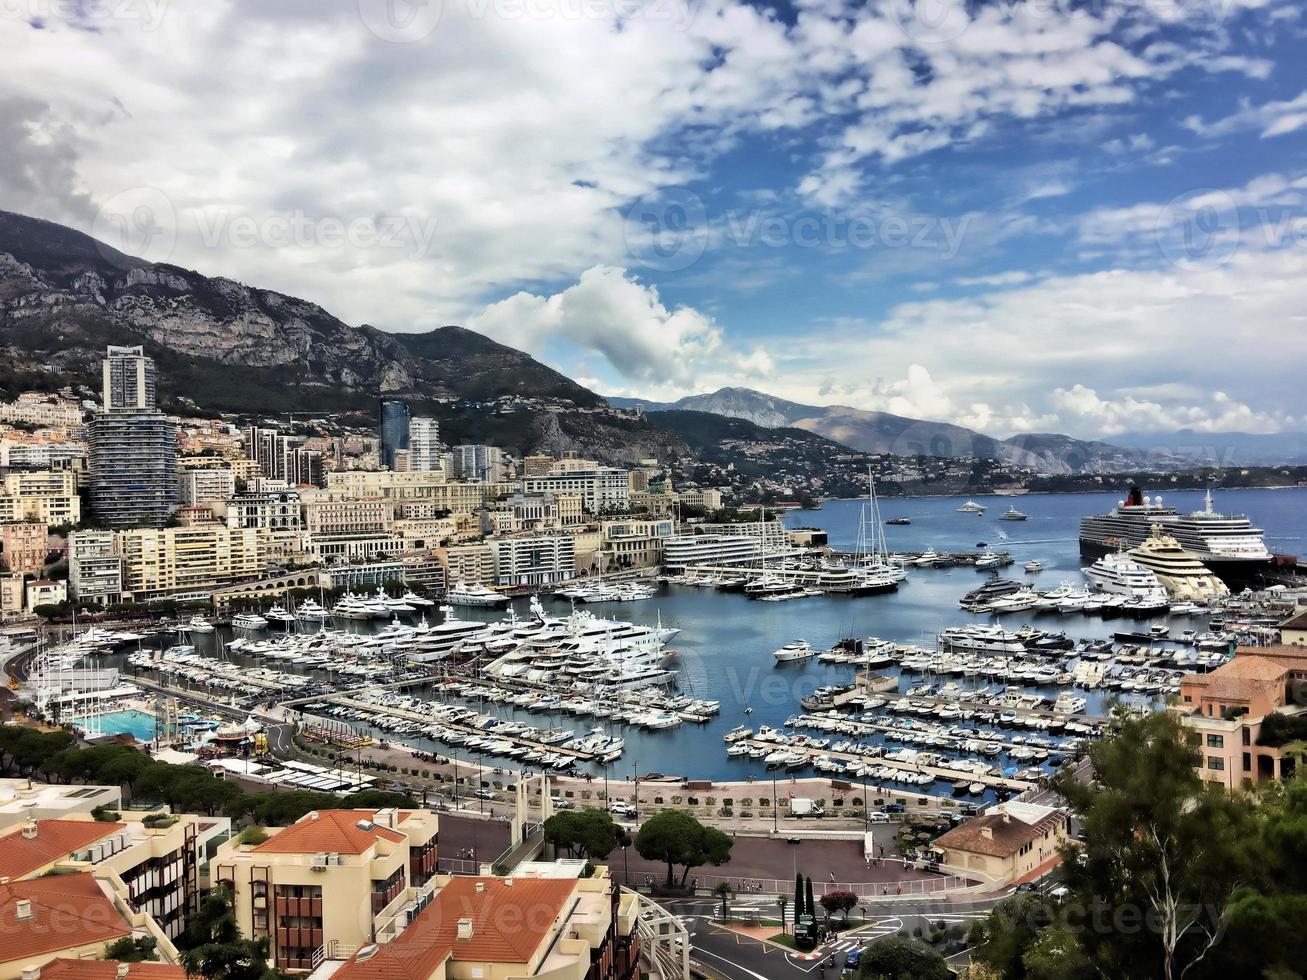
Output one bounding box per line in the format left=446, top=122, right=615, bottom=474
left=127, top=489, right=1307, bottom=792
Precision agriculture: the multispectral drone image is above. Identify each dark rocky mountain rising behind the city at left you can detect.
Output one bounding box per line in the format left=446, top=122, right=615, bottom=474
left=0, top=212, right=685, bottom=463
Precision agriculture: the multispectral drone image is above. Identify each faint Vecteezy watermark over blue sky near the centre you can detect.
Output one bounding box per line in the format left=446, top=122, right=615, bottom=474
left=625, top=187, right=971, bottom=272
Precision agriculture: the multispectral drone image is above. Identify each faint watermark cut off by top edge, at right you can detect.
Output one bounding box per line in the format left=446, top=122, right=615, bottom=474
left=886, top=0, right=1235, bottom=46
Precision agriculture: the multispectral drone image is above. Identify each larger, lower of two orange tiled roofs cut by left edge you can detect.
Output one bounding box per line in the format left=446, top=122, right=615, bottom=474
left=0, top=873, right=132, bottom=963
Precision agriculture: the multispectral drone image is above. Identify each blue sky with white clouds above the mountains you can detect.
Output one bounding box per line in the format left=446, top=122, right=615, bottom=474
left=0, top=0, right=1307, bottom=438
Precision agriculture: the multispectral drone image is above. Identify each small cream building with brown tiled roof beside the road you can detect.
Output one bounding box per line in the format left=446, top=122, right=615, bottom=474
left=931, top=800, right=1069, bottom=885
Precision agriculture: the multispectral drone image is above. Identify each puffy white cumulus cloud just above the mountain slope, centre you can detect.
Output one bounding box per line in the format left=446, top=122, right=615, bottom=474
left=468, top=265, right=772, bottom=389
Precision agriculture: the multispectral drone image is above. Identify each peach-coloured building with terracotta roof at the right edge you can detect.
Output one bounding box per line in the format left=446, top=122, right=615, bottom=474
left=1175, top=645, right=1307, bottom=789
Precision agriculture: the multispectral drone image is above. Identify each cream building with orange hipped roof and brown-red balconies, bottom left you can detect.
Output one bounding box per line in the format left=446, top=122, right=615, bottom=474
left=212, top=809, right=438, bottom=970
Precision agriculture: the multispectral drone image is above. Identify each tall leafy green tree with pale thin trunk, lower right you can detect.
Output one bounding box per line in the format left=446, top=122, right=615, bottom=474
left=1052, top=712, right=1256, bottom=980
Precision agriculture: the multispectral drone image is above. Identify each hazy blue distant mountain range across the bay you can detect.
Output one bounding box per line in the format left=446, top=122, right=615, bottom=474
left=622, top=388, right=1141, bottom=474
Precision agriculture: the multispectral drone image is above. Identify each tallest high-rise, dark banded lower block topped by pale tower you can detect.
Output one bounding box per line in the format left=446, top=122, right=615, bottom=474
left=88, top=348, right=176, bottom=528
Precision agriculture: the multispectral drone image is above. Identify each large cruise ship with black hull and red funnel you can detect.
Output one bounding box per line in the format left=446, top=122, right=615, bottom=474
left=1080, top=487, right=1272, bottom=583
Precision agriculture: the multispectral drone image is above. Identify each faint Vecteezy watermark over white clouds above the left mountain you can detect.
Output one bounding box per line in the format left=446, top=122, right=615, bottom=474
left=91, top=187, right=437, bottom=265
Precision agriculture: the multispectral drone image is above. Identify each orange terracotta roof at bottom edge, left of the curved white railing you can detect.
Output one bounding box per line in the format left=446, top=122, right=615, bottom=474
left=333, top=877, right=576, bottom=980
